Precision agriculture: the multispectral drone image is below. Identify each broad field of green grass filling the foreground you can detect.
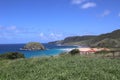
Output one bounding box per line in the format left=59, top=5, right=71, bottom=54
left=0, top=56, right=120, bottom=80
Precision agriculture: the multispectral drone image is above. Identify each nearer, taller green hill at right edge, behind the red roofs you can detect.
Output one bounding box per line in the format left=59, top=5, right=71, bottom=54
left=90, top=30, right=120, bottom=48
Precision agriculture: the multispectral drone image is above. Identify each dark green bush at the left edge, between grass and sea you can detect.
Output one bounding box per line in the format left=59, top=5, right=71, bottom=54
left=0, top=52, right=25, bottom=59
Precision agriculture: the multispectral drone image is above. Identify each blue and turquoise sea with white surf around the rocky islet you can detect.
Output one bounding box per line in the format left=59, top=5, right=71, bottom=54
left=0, top=43, right=78, bottom=58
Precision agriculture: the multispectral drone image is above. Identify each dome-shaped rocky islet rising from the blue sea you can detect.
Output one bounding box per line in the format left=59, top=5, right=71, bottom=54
left=23, top=42, right=45, bottom=50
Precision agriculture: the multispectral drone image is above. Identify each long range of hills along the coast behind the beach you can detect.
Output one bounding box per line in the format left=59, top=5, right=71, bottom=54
left=50, top=29, right=120, bottom=47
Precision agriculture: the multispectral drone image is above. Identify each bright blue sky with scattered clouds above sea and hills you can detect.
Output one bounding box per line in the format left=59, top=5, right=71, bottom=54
left=0, top=0, right=120, bottom=44
